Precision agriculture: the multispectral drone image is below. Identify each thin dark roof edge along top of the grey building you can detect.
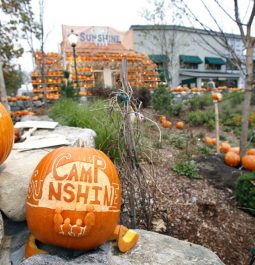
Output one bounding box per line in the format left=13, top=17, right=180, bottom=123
left=129, top=25, right=241, bottom=39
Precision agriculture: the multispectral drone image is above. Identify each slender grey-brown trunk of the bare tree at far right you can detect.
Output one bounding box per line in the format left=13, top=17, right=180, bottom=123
left=240, top=41, right=253, bottom=157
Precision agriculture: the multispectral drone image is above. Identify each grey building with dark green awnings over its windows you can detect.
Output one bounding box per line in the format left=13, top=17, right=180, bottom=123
left=130, top=25, right=247, bottom=88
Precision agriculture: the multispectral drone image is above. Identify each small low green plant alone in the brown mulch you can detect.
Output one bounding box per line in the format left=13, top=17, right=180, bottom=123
left=173, top=160, right=200, bottom=179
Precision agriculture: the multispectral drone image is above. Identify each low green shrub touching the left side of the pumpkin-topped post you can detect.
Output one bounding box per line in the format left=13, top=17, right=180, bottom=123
left=187, top=110, right=215, bottom=129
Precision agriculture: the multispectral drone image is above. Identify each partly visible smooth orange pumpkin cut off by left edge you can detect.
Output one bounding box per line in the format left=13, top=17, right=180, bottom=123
left=0, top=103, right=14, bottom=165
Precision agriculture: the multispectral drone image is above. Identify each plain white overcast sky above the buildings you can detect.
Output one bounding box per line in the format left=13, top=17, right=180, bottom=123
left=19, top=0, right=255, bottom=71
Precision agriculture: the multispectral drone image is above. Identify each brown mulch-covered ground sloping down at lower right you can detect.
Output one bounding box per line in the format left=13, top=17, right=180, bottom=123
left=136, top=107, right=255, bottom=265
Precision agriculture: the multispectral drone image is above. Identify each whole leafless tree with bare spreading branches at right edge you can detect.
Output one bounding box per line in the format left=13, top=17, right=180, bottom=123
left=171, top=0, right=255, bottom=156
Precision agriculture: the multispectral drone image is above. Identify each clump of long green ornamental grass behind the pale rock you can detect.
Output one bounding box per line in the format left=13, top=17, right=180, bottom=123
left=48, top=99, right=123, bottom=160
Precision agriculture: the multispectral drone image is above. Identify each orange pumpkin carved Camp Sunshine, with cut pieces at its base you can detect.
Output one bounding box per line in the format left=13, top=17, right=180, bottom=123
left=25, top=147, right=139, bottom=257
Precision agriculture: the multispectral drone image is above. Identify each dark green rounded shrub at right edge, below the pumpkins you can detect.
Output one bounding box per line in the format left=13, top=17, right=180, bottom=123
left=235, top=172, right=255, bottom=215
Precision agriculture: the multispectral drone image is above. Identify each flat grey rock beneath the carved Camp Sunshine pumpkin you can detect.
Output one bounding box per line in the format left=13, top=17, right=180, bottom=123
left=16, top=230, right=224, bottom=265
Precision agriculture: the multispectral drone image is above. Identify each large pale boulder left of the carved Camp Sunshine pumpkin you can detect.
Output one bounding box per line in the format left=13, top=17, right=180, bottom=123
left=0, top=149, right=49, bottom=221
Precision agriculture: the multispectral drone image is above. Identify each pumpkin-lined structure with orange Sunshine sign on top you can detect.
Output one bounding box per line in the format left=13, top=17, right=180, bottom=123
left=61, top=25, right=159, bottom=92
